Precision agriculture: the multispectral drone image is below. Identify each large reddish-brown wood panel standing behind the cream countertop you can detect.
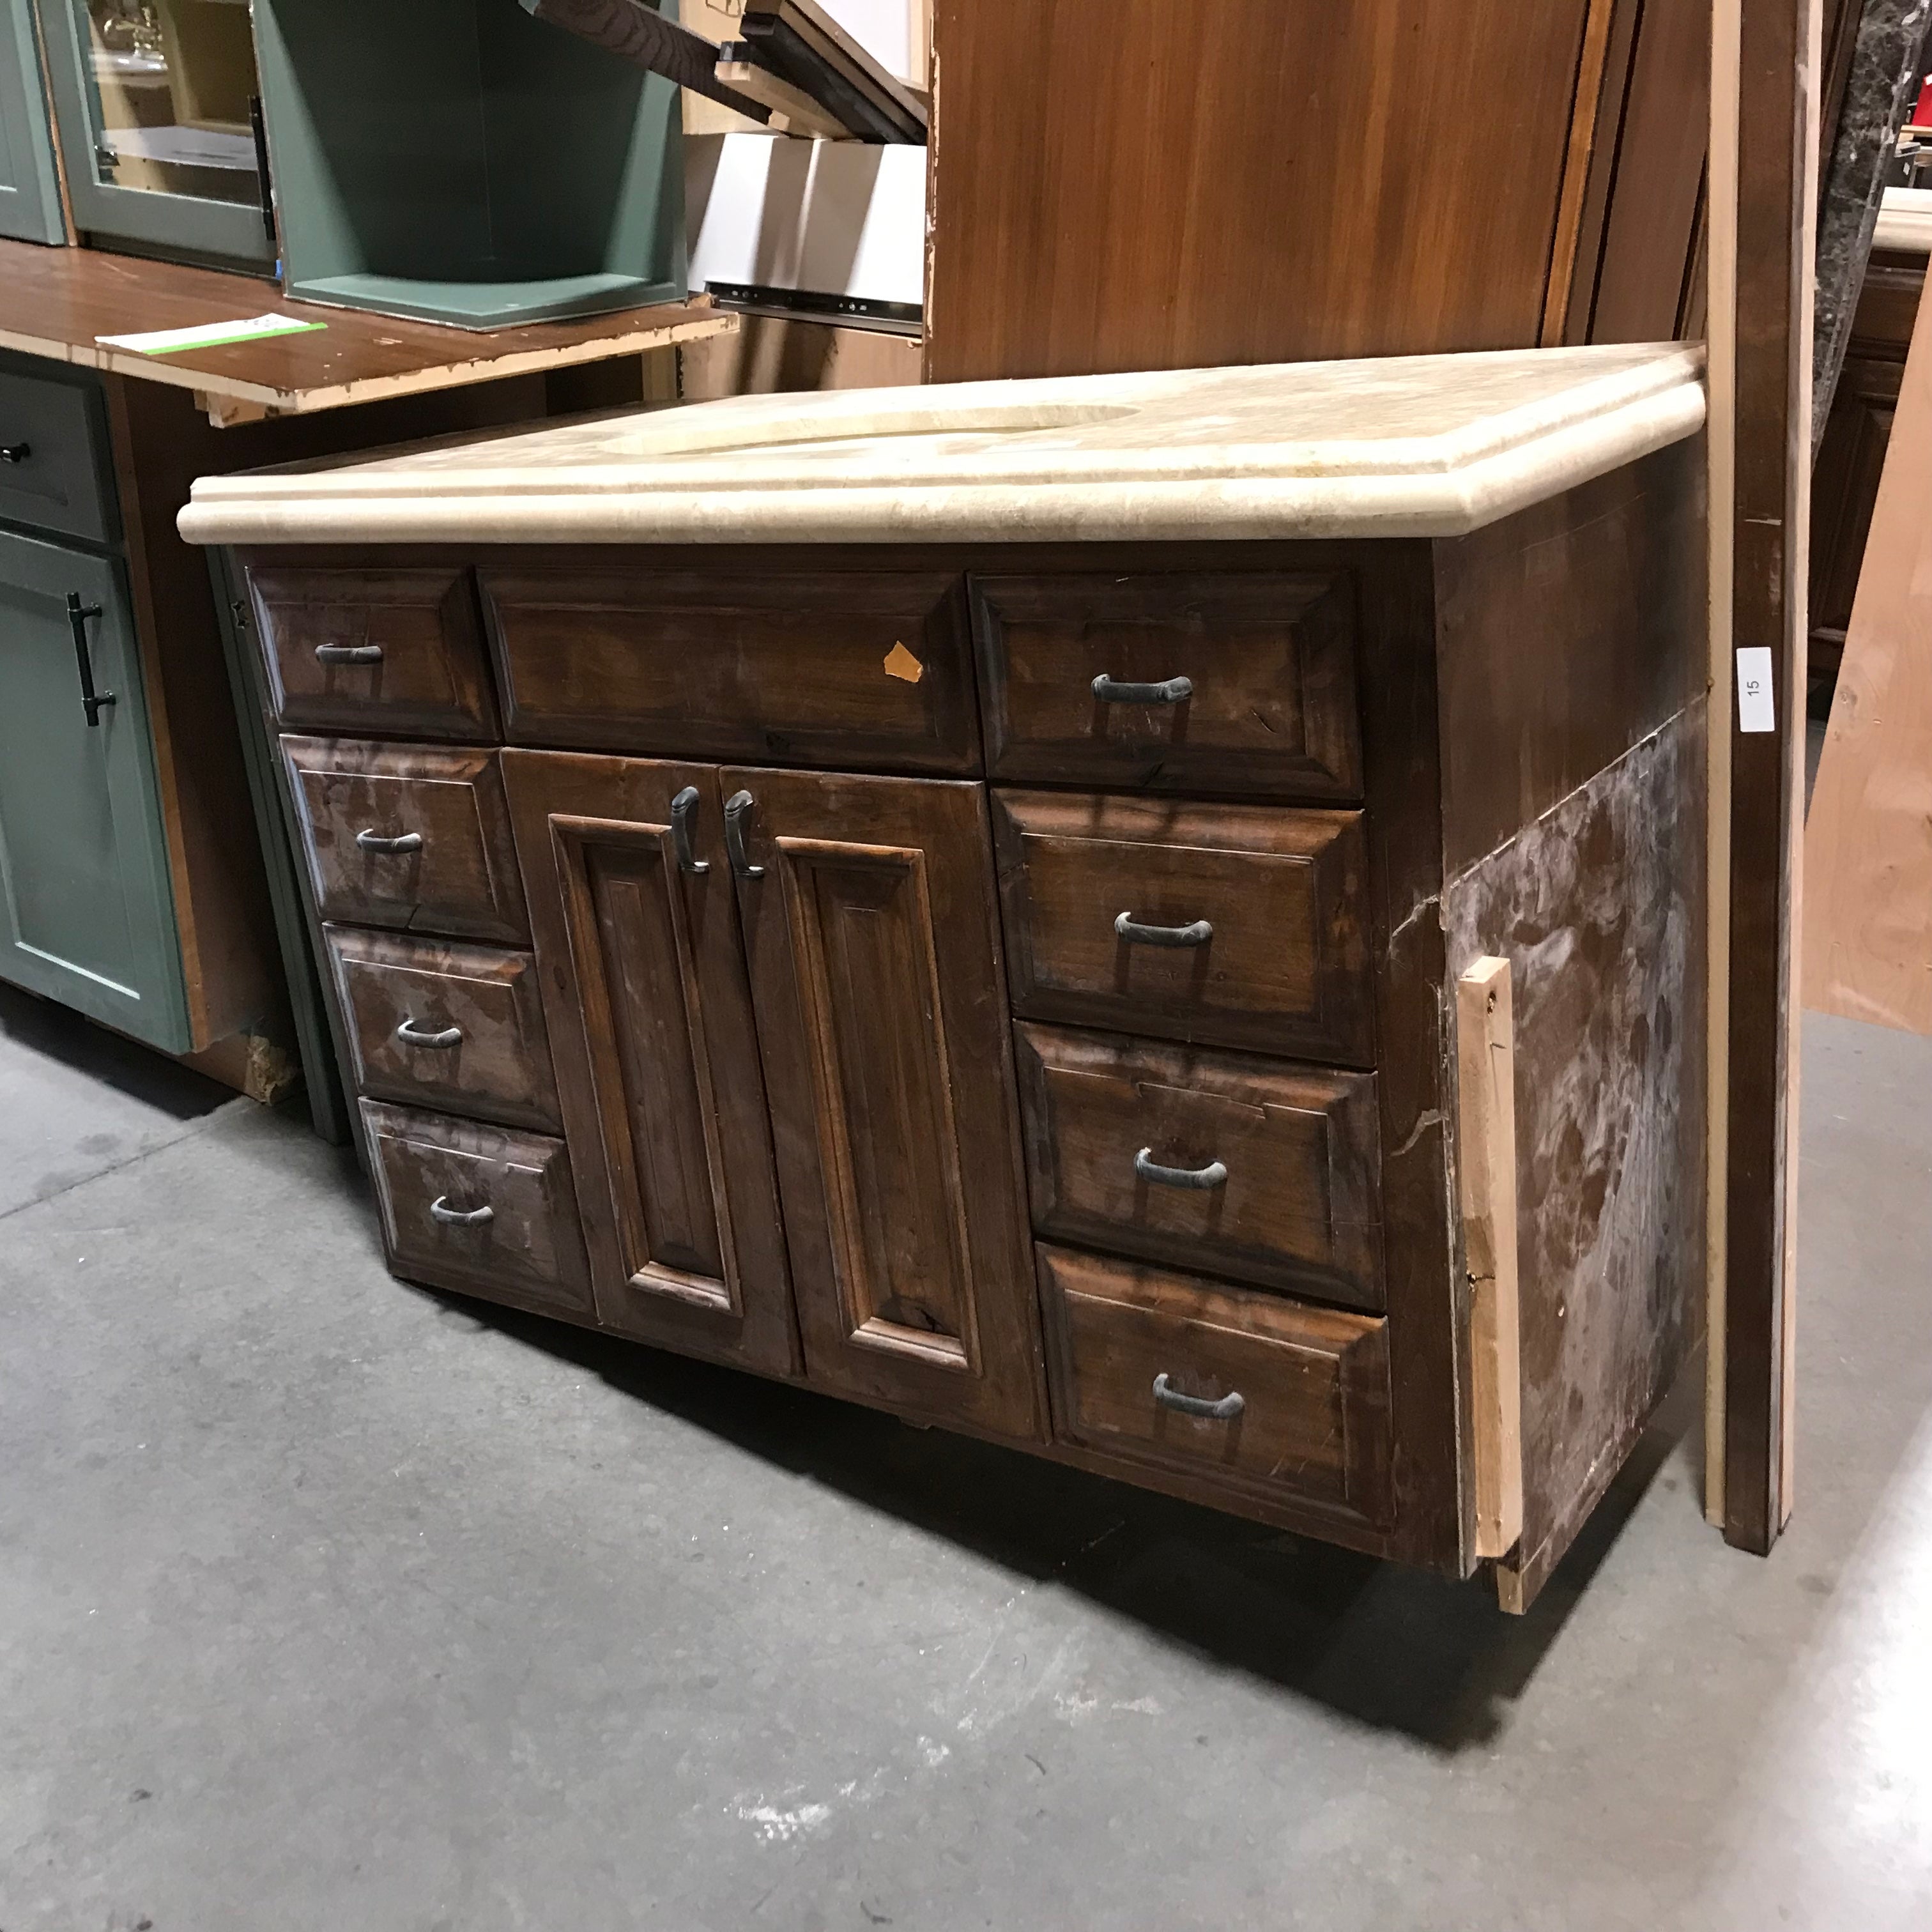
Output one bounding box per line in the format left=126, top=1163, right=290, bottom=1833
left=925, top=0, right=1708, bottom=381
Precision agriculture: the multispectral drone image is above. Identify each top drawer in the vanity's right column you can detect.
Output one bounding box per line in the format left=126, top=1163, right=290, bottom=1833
left=972, top=576, right=1362, bottom=800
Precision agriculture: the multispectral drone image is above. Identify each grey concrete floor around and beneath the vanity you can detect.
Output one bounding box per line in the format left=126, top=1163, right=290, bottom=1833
left=0, top=991, right=1932, bottom=1932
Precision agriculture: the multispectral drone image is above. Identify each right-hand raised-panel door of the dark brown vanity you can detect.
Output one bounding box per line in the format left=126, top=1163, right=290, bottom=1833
left=721, top=769, right=1043, bottom=1438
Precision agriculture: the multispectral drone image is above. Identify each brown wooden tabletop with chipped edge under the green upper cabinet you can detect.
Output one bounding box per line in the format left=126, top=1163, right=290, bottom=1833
left=0, top=241, right=738, bottom=423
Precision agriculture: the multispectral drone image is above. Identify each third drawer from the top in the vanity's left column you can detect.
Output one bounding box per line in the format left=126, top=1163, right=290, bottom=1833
left=325, top=925, right=562, bottom=1132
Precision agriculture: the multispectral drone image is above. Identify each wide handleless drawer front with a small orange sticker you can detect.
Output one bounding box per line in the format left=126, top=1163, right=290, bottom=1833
left=483, top=560, right=979, bottom=773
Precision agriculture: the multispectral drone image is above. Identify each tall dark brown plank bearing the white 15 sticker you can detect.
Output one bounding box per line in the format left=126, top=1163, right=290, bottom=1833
left=1717, top=0, right=1822, bottom=1553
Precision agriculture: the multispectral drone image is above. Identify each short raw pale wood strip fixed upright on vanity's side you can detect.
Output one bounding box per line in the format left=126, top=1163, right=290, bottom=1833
left=1457, top=958, right=1522, bottom=1568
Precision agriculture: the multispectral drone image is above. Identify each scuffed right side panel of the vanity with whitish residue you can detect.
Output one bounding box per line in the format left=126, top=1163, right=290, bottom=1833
left=1436, top=438, right=1708, bottom=1609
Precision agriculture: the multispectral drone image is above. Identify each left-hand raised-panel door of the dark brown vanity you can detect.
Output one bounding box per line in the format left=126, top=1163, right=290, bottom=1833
left=502, top=751, right=798, bottom=1376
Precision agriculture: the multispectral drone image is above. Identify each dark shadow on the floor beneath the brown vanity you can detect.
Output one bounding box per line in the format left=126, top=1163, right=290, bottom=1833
left=413, top=1289, right=1702, bottom=1754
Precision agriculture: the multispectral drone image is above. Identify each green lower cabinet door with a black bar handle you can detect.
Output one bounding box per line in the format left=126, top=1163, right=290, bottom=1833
left=0, top=533, right=193, bottom=1053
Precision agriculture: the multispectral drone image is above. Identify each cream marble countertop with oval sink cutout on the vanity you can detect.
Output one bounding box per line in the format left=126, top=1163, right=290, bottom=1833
left=180, top=344, right=1704, bottom=545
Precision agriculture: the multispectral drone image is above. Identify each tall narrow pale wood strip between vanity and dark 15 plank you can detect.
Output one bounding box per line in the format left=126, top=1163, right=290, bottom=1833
left=1704, top=0, right=1743, bottom=1528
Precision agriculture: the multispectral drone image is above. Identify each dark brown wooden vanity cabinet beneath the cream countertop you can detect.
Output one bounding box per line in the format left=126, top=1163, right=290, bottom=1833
left=240, top=442, right=1706, bottom=1607
